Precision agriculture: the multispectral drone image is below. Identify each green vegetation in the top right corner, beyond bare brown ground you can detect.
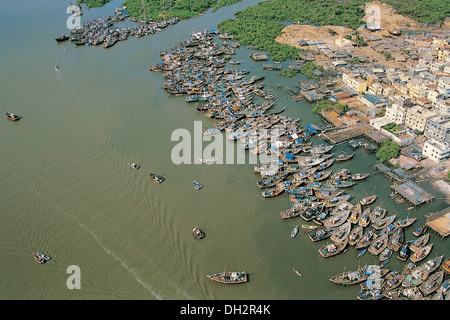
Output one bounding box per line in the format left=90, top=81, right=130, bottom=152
left=383, top=0, right=450, bottom=23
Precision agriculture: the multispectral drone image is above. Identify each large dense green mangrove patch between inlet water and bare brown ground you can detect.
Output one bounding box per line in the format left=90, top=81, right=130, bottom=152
left=218, top=0, right=364, bottom=61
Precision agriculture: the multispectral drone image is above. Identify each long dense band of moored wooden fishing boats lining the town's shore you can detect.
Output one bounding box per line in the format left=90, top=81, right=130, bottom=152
left=150, top=31, right=448, bottom=299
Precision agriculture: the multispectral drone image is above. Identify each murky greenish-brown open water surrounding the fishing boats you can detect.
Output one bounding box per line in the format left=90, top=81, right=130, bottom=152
left=0, top=0, right=449, bottom=300
